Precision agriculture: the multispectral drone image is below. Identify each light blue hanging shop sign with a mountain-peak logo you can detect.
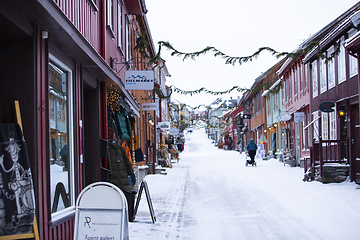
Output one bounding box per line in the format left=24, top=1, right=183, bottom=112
left=125, top=70, right=154, bottom=90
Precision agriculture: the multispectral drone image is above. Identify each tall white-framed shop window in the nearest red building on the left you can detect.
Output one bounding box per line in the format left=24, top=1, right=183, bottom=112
left=48, top=56, right=75, bottom=220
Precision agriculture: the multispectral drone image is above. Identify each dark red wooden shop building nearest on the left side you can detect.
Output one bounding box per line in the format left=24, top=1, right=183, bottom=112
left=0, top=0, right=154, bottom=239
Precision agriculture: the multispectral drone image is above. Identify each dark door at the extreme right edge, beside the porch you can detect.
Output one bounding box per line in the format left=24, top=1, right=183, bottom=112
left=350, top=104, right=360, bottom=184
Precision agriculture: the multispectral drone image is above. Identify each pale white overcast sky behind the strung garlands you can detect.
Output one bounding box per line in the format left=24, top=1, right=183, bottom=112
left=145, top=0, right=358, bottom=107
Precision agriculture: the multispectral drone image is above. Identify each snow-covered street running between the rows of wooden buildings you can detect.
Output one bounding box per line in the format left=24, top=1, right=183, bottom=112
left=129, top=129, right=360, bottom=240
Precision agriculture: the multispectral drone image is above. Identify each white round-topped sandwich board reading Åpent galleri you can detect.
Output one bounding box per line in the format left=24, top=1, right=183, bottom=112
left=74, top=182, right=129, bottom=240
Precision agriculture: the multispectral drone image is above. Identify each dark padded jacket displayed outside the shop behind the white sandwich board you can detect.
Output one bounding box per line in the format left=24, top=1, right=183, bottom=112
left=109, top=141, right=136, bottom=193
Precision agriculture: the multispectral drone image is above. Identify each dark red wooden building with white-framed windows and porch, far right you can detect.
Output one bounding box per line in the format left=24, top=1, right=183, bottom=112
left=303, top=3, right=360, bottom=180
